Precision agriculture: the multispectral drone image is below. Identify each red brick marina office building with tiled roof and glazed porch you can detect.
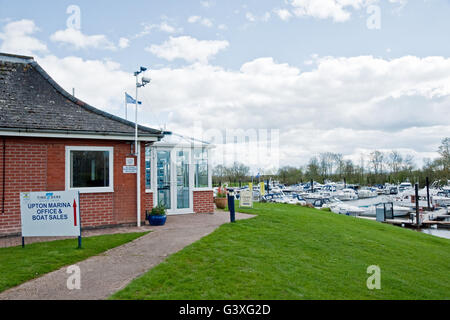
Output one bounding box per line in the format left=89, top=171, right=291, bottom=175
left=0, top=53, right=214, bottom=235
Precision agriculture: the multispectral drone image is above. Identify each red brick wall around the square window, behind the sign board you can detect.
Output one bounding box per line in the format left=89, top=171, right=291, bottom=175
left=0, top=137, right=153, bottom=234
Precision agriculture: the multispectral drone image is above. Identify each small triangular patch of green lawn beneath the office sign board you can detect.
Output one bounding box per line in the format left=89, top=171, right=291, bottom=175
left=0, top=233, right=147, bottom=292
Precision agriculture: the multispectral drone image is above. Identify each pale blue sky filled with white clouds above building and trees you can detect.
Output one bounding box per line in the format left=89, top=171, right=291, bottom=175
left=0, top=0, right=450, bottom=172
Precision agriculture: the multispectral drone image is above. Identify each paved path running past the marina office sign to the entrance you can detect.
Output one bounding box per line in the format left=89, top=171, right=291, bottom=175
left=0, top=212, right=253, bottom=300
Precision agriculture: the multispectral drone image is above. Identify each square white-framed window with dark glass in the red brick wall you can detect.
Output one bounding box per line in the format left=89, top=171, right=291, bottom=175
left=66, top=147, right=114, bottom=193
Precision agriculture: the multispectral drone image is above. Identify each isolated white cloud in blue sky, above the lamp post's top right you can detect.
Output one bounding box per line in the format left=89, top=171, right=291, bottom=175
left=146, top=36, right=229, bottom=63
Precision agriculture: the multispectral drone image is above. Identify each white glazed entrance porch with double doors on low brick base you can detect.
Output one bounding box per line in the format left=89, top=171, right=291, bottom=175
left=145, top=133, right=214, bottom=215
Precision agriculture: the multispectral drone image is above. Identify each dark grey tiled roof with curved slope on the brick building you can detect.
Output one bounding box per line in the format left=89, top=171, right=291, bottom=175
left=0, top=53, right=163, bottom=138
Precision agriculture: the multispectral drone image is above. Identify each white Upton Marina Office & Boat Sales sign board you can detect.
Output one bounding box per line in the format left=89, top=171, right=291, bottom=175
left=20, top=191, right=81, bottom=237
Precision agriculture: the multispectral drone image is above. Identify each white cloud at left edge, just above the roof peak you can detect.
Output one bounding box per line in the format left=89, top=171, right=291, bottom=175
left=0, top=19, right=48, bottom=55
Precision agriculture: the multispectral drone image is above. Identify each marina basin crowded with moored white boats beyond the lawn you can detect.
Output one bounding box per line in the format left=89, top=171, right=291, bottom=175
left=219, top=180, right=450, bottom=238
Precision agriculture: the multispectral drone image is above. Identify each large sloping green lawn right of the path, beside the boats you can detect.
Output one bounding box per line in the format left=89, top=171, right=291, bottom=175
left=111, top=204, right=450, bottom=300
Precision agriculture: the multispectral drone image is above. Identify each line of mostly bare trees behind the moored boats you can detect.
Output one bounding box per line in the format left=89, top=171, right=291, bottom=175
left=213, top=138, right=450, bottom=186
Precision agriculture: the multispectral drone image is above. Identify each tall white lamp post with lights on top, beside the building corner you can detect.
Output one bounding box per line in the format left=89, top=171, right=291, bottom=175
left=134, top=67, right=151, bottom=227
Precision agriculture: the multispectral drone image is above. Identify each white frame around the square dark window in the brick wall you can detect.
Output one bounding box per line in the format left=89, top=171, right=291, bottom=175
left=66, top=146, right=114, bottom=193
